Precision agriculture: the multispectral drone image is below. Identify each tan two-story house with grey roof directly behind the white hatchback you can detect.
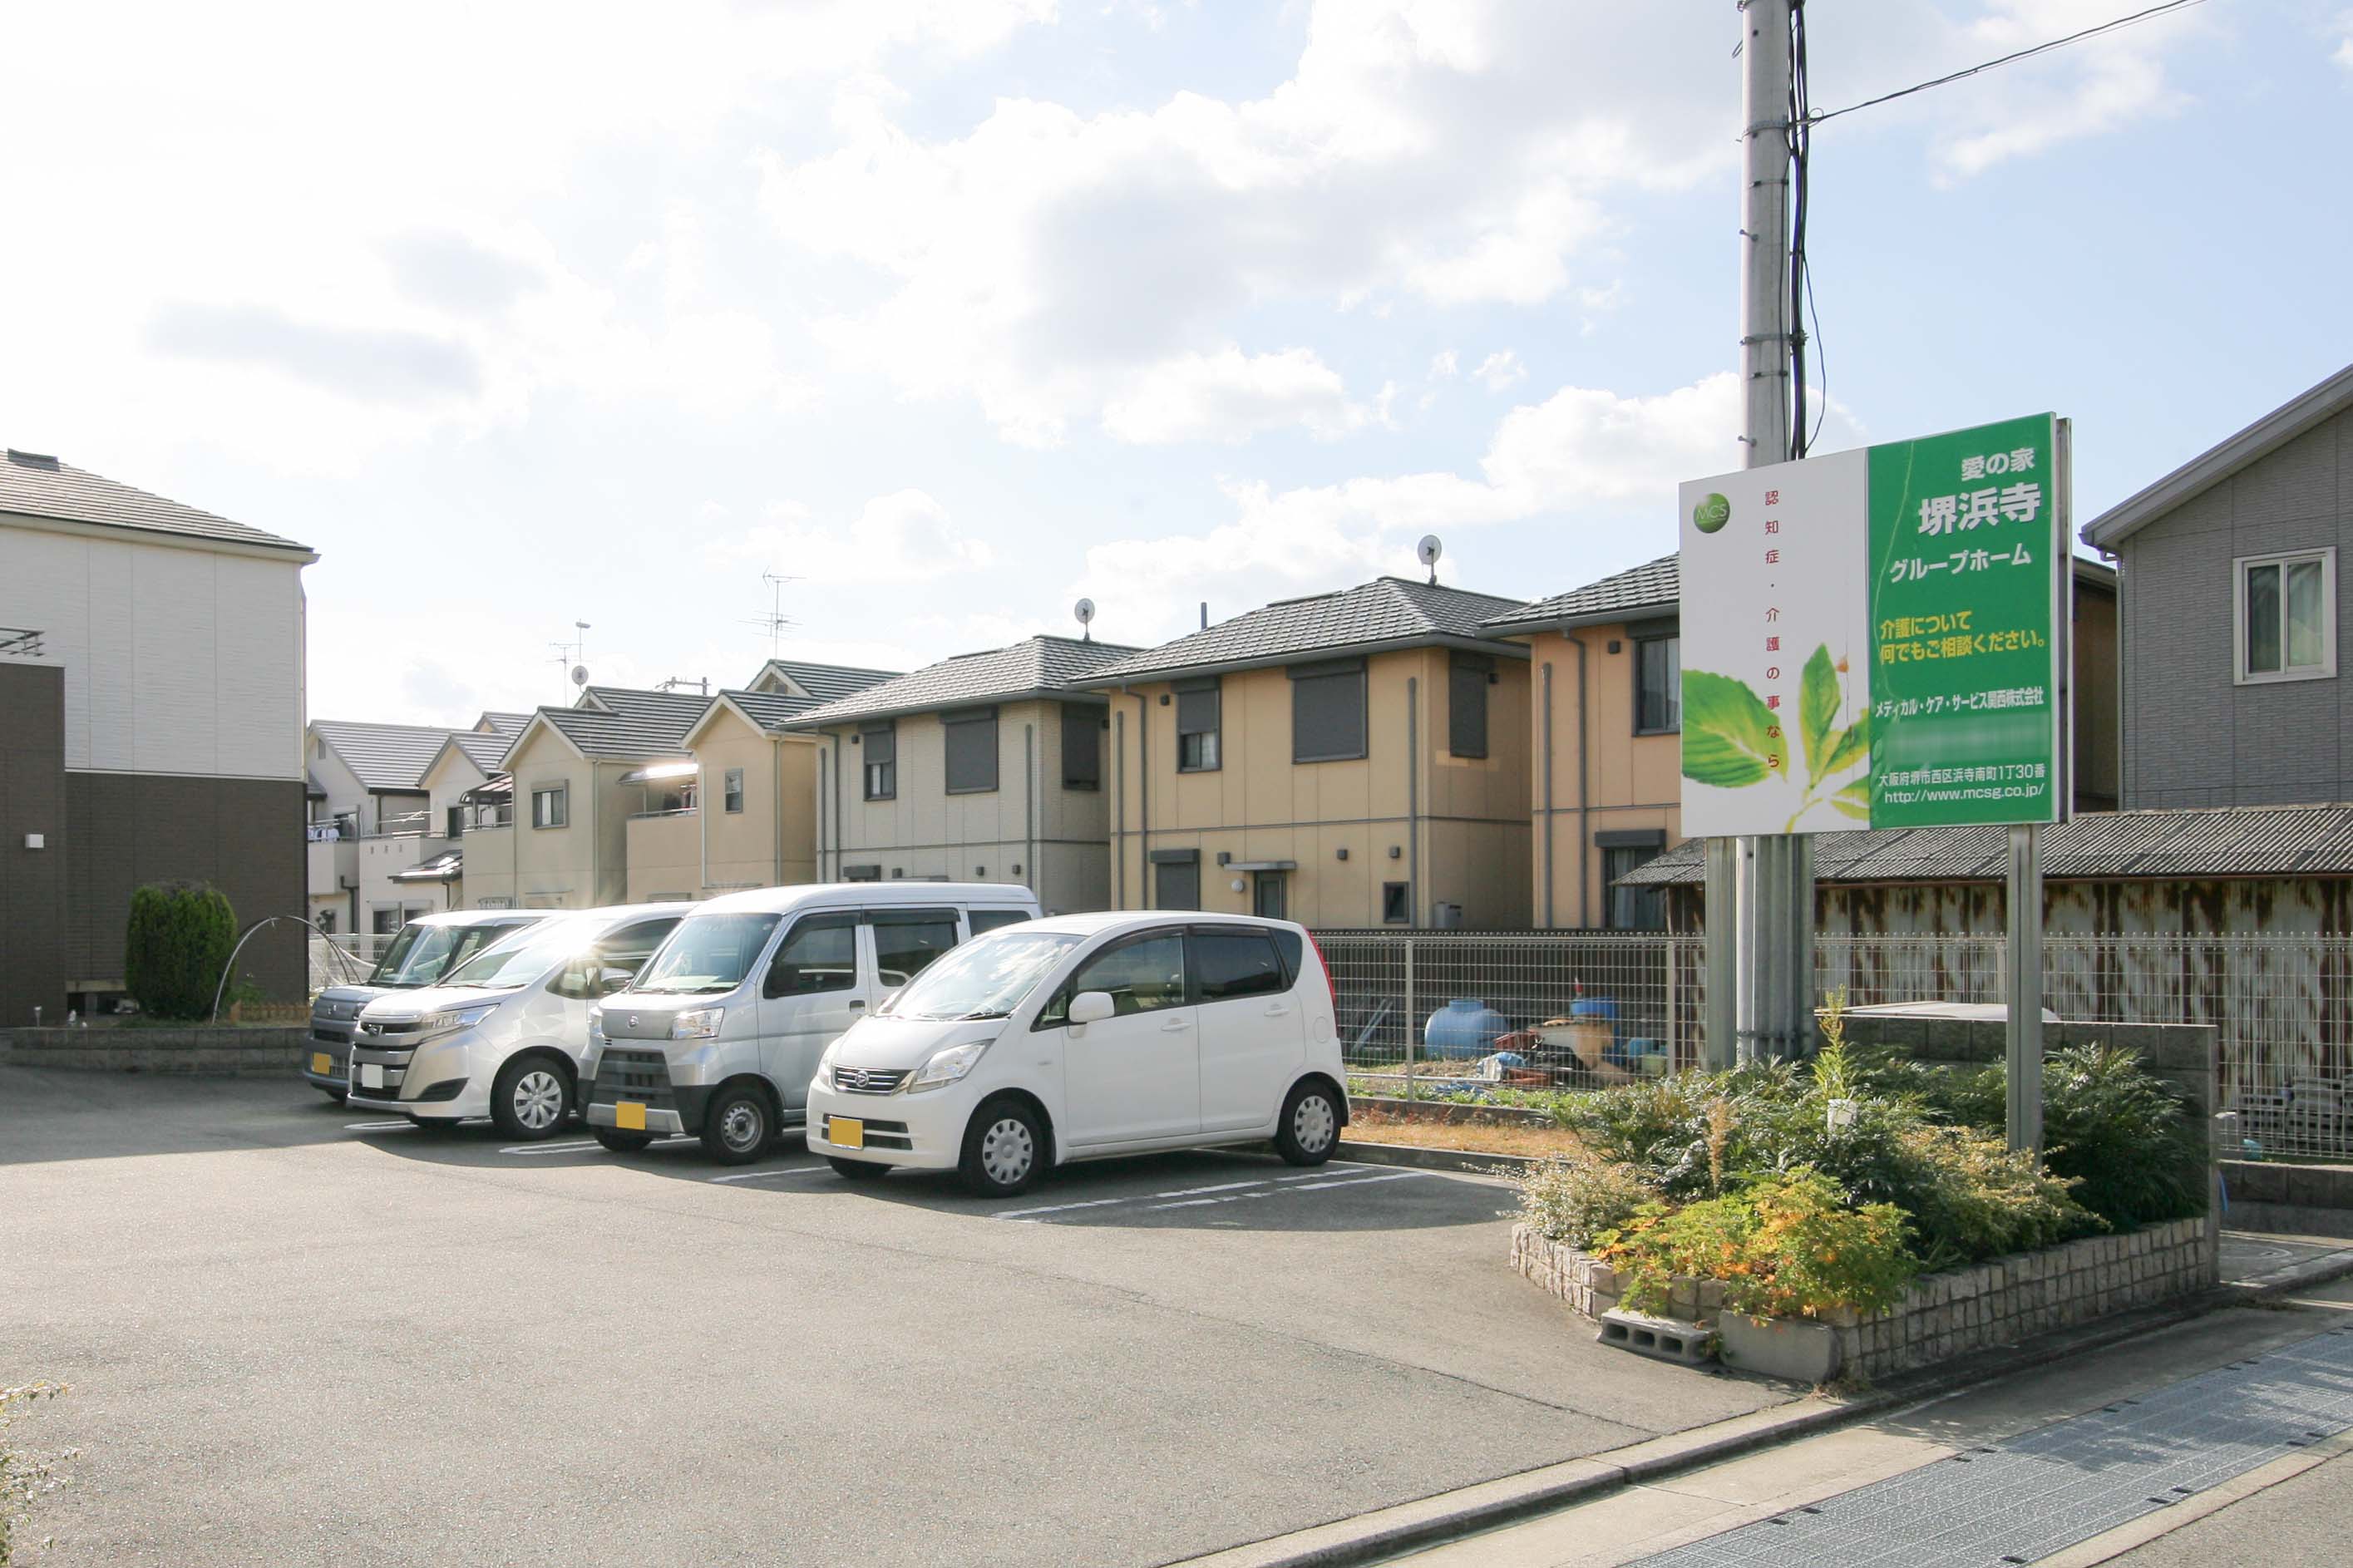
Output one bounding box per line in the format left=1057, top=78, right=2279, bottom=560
left=1092, top=577, right=1530, bottom=928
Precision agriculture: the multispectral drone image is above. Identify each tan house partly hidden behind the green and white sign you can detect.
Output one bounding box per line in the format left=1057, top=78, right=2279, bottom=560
left=1485, top=555, right=2118, bottom=930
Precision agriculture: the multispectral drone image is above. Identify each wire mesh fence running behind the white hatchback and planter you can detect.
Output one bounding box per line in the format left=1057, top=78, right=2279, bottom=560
left=1315, top=930, right=2353, bottom=1158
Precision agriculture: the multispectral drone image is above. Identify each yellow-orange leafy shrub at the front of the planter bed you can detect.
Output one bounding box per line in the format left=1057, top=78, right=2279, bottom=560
left=1600, top=1168, right=1920, bottom=1319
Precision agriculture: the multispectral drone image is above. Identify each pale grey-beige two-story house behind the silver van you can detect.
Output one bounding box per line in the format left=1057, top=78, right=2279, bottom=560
left=793, top=636, right=1137, bottom=911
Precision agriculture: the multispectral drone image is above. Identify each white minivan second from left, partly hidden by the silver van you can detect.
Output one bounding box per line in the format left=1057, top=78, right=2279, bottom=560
left=346, top=904, right=694, bottom=1140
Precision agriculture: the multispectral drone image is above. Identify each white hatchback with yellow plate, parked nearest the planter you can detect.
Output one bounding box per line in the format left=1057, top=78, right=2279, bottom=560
left=807, top=911, right=1349, bottom=1196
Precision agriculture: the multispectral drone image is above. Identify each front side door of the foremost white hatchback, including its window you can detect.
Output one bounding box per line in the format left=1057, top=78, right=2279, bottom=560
left=1038, top=930, right=1200, bottom=1149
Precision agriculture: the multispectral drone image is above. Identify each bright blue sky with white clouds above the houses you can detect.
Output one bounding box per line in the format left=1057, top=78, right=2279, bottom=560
left=0, top=0, right=2353, bottom=722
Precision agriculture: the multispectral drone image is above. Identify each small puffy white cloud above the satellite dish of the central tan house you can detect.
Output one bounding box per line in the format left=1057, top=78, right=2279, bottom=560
left=1103, top=343, right=1377, bottom=445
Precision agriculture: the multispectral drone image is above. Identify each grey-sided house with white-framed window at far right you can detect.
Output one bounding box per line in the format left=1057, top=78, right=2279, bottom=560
left=2083, top=365, right=2353, bottom=807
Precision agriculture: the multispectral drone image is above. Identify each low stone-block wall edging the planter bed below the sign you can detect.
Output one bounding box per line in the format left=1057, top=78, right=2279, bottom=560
left=1511, top=1217, right=2222, bottom=1378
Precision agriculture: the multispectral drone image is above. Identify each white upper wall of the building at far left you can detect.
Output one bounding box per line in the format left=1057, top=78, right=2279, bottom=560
left=0, top=515, right=303, bottom=779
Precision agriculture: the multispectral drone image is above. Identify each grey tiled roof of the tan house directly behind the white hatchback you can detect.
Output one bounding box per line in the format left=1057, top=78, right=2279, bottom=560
left=1092, top=577, right=1520, bottom=685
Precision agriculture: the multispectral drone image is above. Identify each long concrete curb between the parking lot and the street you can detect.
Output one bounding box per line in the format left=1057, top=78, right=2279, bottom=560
left=1165, top=1224, right=2353, bottom=1568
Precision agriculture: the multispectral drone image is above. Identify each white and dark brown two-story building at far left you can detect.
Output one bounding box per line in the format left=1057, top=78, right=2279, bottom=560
left=0, top=450, right=318, bottom=1027
